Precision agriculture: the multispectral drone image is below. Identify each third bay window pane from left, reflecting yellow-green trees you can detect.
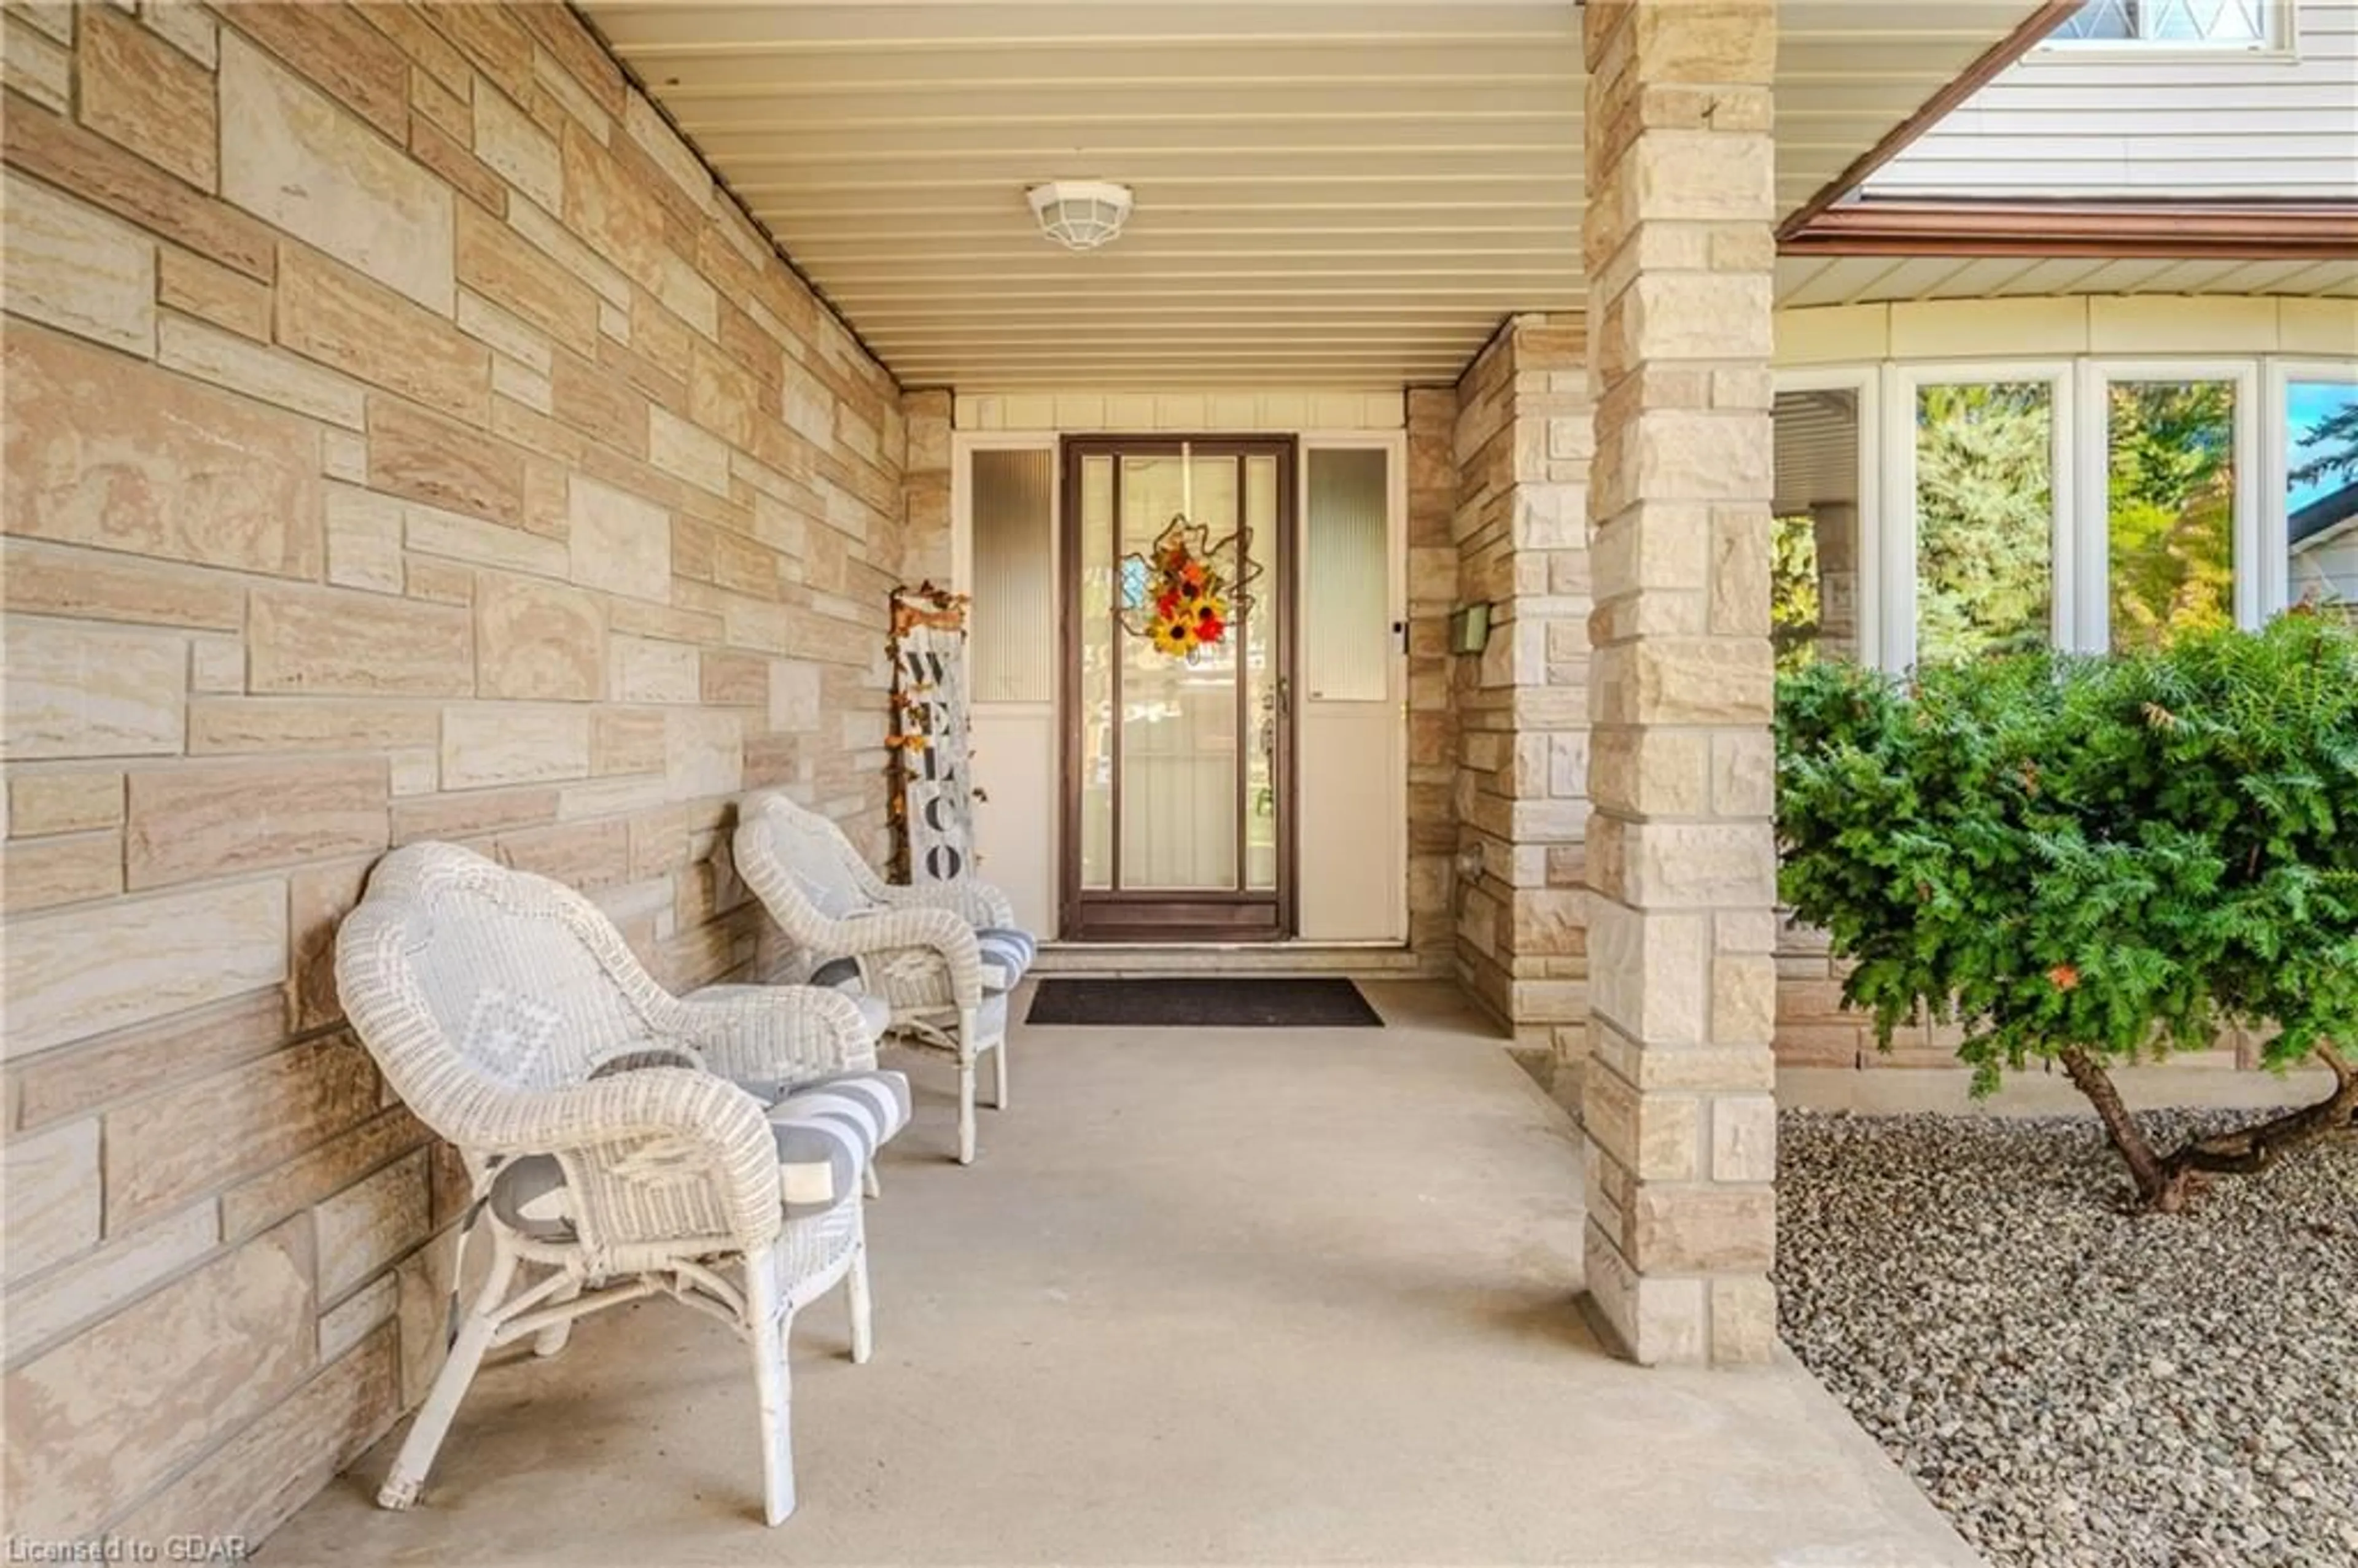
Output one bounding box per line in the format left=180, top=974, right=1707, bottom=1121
left=2106, top=382, right=2235, bottom=648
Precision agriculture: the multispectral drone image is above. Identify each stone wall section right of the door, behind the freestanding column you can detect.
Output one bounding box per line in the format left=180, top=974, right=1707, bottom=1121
left=1452, top=316, right=1594, bottom=1063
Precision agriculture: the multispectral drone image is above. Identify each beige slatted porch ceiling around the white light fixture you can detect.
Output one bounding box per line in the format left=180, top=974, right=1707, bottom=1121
left=585, top=0, right=2035, bottom=387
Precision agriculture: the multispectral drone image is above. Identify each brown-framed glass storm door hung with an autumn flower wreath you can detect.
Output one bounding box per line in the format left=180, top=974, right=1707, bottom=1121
left=1061, top=437, right=1294, bottom=941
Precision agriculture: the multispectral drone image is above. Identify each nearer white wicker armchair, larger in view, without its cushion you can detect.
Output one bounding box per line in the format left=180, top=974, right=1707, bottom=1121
left=335, top=844, right=896, bottom=1523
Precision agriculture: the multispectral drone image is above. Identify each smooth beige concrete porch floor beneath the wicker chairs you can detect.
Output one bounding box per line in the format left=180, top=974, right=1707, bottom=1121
left=262, top=984, right=1976, bottom=1568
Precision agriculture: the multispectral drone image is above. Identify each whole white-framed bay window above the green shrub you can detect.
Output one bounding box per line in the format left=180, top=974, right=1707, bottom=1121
left=1771, top=356, right=2358, bottom=670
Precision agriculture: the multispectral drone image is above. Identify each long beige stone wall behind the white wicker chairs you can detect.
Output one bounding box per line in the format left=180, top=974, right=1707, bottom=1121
left=0, top=2, right=908, bottom=1537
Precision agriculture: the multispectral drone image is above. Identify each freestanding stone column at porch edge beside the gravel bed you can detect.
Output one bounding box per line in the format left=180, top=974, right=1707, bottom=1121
left=1582, top=0, right=1776, bottom=1363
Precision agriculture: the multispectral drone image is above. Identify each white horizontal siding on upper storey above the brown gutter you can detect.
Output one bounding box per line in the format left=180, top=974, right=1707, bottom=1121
left=1867, top=0, right=2358, bottom=200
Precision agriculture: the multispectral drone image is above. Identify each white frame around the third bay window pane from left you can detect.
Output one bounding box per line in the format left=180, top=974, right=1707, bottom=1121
left=2068, top=356, right=2285, bottom=653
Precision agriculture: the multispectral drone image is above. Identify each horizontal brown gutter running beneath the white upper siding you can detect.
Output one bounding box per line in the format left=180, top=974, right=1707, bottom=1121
left=1778, top=200, right=2358, bottom=262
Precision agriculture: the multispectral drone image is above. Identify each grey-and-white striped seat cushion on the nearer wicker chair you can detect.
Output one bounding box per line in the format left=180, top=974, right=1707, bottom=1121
left=491, top=1071, right=910, bottom=1243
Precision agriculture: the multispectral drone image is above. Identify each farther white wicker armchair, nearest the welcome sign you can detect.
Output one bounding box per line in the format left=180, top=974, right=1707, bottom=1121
left=736, top=790, right=1033, bottom=1165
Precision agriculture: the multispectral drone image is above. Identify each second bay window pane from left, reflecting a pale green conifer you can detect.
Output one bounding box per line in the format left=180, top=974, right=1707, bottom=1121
left=1917, top=382, right=2054, bottom=662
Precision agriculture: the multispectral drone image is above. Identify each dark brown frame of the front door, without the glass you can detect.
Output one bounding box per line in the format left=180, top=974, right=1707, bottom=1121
left=1056, top=432, right=1302, bottom=941
